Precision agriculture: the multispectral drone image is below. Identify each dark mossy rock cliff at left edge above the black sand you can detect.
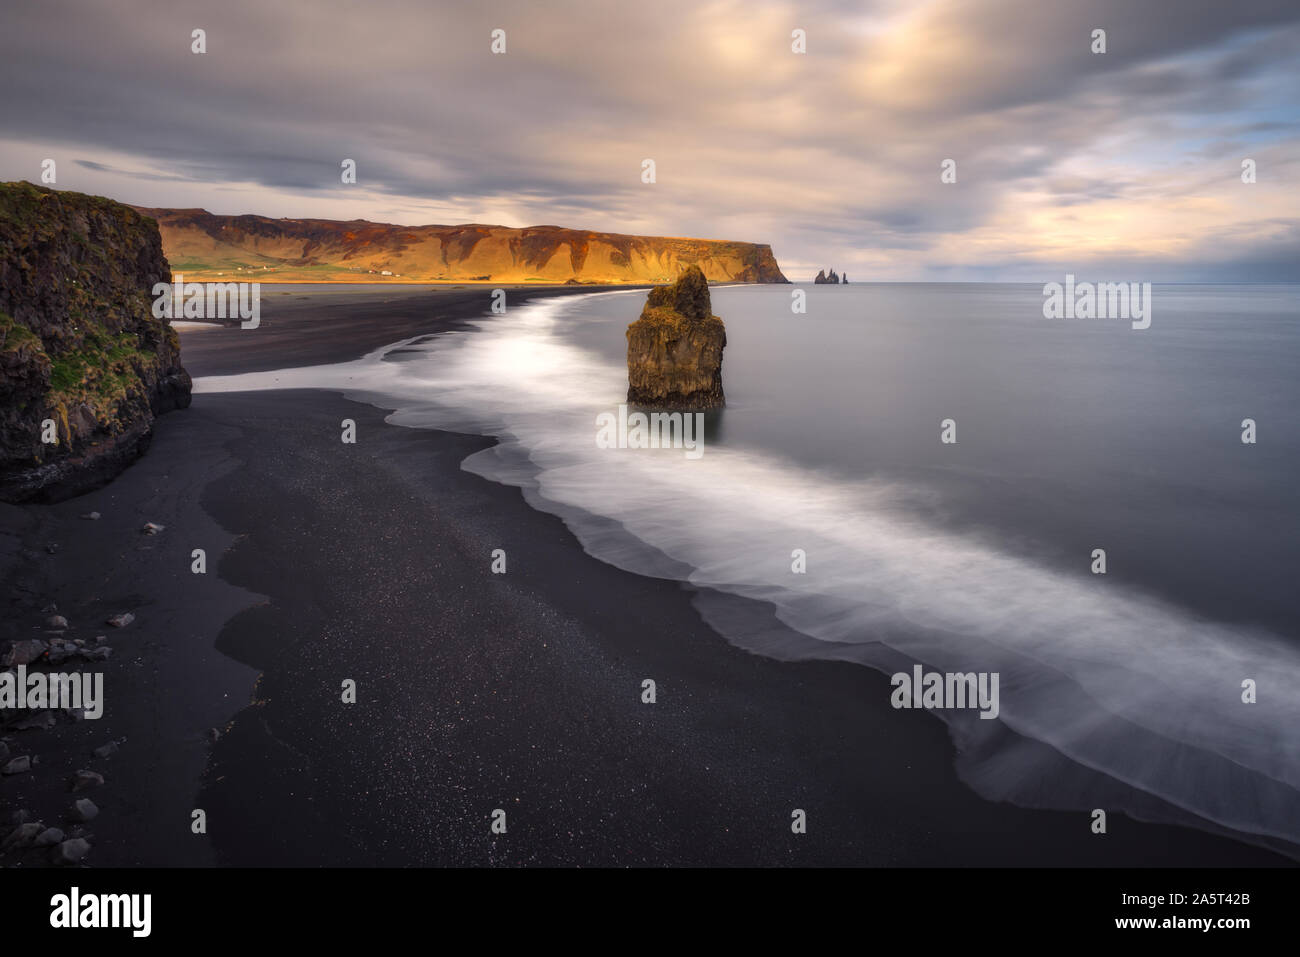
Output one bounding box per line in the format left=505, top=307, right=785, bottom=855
left=0, top=183, right=190, bottom=502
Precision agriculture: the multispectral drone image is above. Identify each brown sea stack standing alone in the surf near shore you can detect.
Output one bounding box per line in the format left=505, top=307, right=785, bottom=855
left=628, top=265, right=727, bottom=411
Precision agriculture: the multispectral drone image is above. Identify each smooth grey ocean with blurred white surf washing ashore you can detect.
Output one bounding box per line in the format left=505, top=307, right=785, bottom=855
left=195, top=283, right=1300, bottom=856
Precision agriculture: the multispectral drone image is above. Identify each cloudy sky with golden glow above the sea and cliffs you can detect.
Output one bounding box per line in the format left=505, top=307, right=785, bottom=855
left=0, top=0, right=1300, bottom=282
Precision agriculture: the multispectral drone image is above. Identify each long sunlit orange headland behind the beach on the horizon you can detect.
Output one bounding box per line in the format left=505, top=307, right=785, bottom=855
left=131, top=208, right=788, bottom=283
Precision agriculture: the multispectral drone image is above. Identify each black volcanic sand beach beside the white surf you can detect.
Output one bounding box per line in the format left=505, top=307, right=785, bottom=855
left=0, top=290, right=1286, bottom=866
